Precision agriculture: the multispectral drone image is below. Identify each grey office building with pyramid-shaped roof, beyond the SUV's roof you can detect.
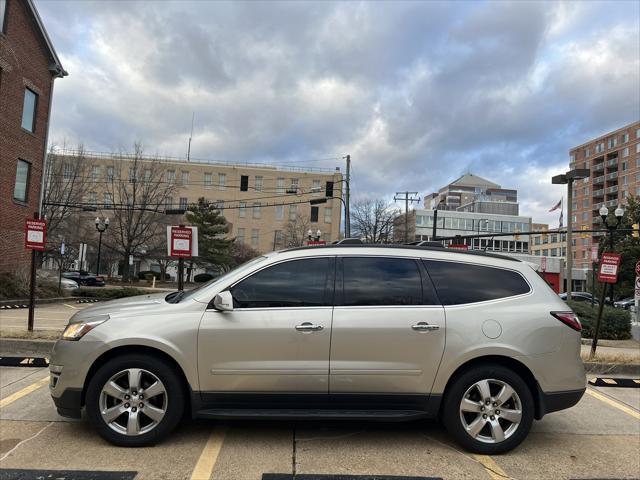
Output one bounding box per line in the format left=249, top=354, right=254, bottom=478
left=424, top=173, right=518, bottom=216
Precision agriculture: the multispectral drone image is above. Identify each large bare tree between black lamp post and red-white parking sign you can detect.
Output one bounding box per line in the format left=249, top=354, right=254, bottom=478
left=105, top=143, right=177, bottom=281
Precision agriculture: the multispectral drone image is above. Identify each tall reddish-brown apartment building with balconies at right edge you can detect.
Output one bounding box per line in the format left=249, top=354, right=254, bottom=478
left=569, top=122, right=640, bottom=269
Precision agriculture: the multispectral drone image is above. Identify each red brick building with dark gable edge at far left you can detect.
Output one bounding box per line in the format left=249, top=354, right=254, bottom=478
left=0, top=0, right=67, bottom=271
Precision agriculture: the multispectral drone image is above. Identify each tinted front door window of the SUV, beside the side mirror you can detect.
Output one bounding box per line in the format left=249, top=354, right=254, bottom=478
left=230, top=257, right=335, bottom=308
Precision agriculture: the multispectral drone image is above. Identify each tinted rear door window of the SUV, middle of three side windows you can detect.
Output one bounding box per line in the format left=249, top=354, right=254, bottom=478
left=342, top=257, right=423, bottom=306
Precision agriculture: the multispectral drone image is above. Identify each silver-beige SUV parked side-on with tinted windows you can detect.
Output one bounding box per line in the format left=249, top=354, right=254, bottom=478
left=50, top=245, right=586, bottom=454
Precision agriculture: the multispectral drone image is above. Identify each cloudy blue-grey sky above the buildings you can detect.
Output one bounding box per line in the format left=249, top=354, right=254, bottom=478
left=36, top=0, right=640, bottom=223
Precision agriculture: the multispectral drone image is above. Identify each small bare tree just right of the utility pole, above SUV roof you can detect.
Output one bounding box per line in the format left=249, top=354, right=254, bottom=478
left=351, top=198, right=399, bottom=243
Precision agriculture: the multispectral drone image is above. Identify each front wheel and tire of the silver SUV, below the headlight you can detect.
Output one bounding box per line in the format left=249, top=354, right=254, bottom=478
left=86, top=354, right=185, bottom=447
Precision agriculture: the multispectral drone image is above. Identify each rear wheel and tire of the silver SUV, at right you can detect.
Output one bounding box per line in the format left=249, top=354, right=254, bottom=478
left=442, top=364, right=534, bottom=455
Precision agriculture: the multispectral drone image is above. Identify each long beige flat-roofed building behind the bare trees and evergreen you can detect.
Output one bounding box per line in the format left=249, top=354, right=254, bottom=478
left=51, top=152, right=342, bottom=252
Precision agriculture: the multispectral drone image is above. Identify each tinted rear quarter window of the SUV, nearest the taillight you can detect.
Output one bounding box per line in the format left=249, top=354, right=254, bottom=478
left=423, top=260, right=531, bottom=305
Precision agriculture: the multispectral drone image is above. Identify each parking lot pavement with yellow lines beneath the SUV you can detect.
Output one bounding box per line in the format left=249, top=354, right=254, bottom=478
left=0, top=367, right=640, bottom=480
